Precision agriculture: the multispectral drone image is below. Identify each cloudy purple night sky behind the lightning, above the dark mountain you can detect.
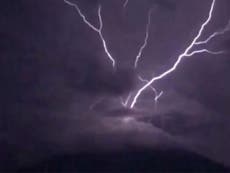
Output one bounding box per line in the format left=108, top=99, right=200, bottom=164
left=0, top=0, right=230, bottom=171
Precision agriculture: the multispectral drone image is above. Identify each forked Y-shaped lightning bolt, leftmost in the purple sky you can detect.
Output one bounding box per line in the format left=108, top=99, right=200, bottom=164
left=64, top=0, right=116, bottom=68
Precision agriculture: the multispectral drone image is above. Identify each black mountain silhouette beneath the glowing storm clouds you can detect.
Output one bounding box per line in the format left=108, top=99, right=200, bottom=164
left=4, top=149, right=230, bottom=173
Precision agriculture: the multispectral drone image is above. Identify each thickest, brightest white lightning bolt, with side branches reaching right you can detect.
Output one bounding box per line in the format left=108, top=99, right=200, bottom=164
left=130, top=0, right=227, bottom=108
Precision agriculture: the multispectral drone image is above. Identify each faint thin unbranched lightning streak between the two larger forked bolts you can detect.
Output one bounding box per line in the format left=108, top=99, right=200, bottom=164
left=134, top=9, right=152, bottom=68
